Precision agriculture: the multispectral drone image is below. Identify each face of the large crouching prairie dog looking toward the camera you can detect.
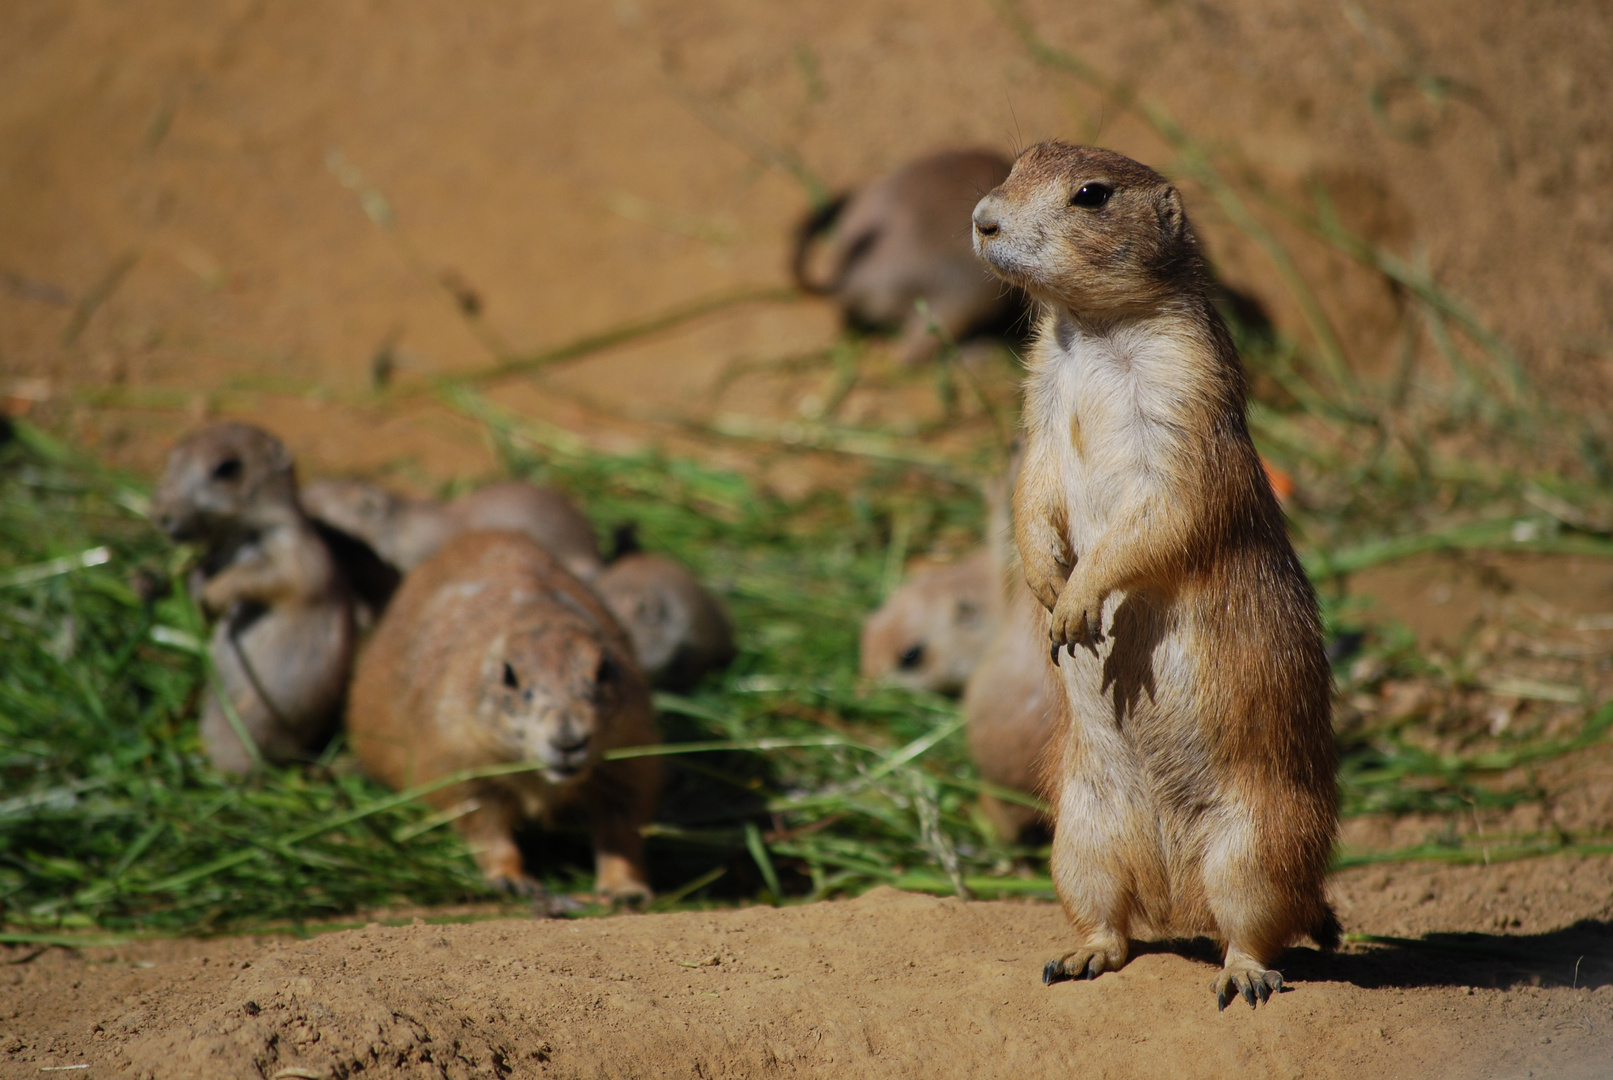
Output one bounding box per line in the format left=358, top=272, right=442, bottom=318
left=479, top=621, right=639, bottom=783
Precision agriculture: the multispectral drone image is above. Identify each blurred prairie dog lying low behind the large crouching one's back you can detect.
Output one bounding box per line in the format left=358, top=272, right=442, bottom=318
left=302, top=480, right=602, bottom=580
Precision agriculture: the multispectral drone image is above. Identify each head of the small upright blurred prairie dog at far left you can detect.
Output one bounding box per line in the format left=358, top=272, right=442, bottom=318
left=152, top=424, right=298, bottom=540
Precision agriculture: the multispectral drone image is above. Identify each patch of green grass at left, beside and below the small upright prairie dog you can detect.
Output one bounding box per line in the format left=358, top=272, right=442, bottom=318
left=0, top=427, right=496, bottom=930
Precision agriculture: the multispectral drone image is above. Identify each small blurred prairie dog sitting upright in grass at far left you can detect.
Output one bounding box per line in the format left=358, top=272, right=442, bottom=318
left=152, top=424, right=353, bottom=774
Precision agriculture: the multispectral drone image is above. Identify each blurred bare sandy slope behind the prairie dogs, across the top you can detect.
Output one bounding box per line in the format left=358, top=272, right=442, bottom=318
left=0, top=0, right=1613, bottom=485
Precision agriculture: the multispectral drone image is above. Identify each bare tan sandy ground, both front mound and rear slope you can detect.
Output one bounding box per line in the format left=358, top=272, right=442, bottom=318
left=0, top=0, right=1613, bottom=1078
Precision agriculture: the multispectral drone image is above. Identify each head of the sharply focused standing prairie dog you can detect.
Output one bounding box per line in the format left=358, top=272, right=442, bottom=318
left=974, top=142, right=1198, bottom=318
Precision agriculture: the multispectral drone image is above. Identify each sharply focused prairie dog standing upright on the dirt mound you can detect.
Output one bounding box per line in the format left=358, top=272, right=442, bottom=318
left=974, top=143, right=1339, bottom=1007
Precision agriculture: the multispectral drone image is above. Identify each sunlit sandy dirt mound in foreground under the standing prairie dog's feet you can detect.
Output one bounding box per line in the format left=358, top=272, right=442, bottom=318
left=0, top=859, right=1613, bottom=1080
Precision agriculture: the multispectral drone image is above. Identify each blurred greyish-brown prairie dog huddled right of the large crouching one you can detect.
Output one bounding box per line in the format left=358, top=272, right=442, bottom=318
left=594, top=551, right=734, bottom=690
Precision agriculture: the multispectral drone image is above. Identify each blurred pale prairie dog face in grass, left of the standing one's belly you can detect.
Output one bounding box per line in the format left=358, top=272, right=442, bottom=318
left=860, top=546, right=1003, bottom=693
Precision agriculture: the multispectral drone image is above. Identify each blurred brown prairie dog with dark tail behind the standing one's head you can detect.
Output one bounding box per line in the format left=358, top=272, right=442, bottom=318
left=790, top=150, right=1024, bottom=364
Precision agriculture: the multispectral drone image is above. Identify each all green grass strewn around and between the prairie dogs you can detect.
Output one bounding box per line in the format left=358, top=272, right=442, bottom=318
left=0, top=377, right=1613, bottom=940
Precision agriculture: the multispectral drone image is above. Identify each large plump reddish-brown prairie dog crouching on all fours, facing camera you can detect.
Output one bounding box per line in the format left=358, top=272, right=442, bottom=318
left=347, top=532, right=661, bottom=899
